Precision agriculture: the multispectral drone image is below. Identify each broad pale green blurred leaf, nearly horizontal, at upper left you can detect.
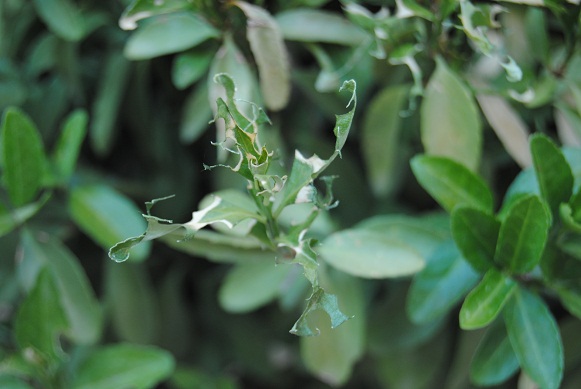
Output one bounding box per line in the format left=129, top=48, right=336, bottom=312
left=124, top=12, right=220, bottom=60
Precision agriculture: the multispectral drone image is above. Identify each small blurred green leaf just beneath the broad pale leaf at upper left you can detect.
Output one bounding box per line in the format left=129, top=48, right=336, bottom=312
left=171, top=47, right=215, bottom=90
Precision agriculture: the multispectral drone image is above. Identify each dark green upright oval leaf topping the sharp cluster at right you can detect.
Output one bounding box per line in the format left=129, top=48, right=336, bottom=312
left=530, top=134, right=574, bottom=214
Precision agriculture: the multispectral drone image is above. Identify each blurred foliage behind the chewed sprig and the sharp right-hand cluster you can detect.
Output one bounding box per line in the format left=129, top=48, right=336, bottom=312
left=0, top=0, right=581, bottom=389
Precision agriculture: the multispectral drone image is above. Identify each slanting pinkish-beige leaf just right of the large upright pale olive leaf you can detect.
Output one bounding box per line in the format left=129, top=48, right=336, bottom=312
left=476, top=94, right=532, bottom=168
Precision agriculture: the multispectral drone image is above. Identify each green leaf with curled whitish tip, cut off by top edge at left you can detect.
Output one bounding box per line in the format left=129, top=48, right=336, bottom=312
left=119, top=0, right=191, bottom=30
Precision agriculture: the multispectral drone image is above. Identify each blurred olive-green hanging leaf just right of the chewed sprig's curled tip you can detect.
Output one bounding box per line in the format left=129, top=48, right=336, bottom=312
left=361, top=85, right=409, bottom=197
